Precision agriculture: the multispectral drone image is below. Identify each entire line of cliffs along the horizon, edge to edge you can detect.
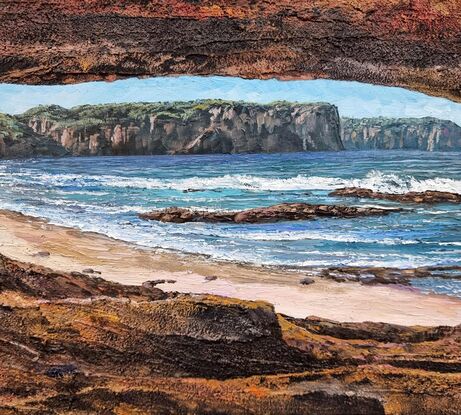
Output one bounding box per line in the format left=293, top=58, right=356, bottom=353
left=0, top=105, right=461, bottom=158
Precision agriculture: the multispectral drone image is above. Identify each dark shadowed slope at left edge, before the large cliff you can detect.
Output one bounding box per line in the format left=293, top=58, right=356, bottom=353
left=0, top=114, right=68, bottom=158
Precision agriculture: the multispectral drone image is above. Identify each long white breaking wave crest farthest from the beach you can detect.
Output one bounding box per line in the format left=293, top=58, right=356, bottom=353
left=5, top=170, right=461, bottom=193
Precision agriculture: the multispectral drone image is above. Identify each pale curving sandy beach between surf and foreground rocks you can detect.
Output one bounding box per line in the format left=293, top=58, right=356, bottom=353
left=0, top=211, right=461, bottom=325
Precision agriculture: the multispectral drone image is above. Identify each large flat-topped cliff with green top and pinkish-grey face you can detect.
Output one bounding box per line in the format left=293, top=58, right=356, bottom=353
left=18, top=101, right=343, bottom=155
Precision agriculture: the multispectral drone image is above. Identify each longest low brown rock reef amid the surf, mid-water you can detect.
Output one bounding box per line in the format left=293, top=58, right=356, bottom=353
left=139, top=203, right=400, bottom=223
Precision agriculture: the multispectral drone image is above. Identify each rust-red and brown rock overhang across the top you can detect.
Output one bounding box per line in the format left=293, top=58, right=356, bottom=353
left=0, top=0, right=461, bottom=101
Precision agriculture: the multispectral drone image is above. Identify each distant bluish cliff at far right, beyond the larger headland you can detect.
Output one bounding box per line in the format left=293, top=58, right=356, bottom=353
left=341, top=117, right=461, bottom=151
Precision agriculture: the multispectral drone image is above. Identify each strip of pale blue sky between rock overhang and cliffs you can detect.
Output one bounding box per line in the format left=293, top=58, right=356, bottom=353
left=0, top=76, right=461, bottom=125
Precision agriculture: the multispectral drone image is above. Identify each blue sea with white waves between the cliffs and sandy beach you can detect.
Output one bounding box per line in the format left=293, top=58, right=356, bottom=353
left=0, top=151, right=461, bottom=293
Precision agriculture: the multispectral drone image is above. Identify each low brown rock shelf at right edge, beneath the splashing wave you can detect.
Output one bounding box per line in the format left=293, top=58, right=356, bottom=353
left=330, top=187, right=461, bottom=203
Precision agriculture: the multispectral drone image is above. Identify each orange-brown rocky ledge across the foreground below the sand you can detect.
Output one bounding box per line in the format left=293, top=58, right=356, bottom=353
left=0, top=255, right=461, bottom=415
